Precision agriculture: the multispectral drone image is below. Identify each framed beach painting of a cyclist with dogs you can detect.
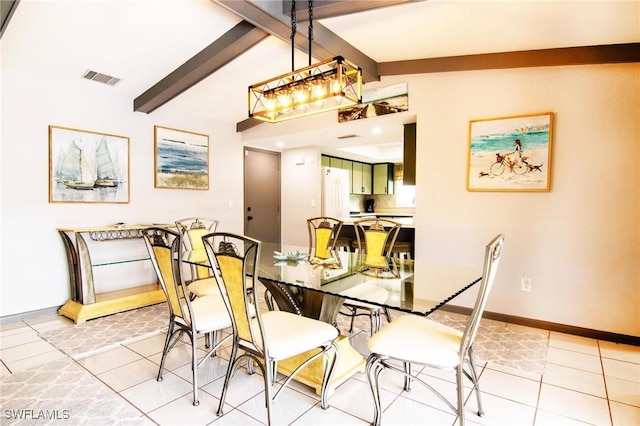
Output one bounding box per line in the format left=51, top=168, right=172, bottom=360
left=467, top=112, right=553, bottom=192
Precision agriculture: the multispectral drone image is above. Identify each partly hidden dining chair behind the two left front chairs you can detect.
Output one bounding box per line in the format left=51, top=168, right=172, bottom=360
left=175, top=217, right=220, bottom=297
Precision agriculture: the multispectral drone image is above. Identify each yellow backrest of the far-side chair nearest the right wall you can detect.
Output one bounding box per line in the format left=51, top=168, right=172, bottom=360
left=354, top=218, right=402, bottom=268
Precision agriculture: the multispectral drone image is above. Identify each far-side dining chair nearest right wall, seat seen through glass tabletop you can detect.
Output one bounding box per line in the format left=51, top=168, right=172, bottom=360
left=340, top=218, right=402, bottom=336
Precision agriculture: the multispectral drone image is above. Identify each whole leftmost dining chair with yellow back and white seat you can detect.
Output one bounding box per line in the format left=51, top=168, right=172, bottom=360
left=142, top=227, right=231, bottom=405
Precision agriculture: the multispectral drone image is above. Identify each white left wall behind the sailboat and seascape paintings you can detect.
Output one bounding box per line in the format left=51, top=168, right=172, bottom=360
left=0, top=33, right=243, bottom=316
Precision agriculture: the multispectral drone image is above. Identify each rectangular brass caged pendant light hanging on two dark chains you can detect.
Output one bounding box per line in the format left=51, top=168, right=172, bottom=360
left=249, top=0, right=362, bottom=123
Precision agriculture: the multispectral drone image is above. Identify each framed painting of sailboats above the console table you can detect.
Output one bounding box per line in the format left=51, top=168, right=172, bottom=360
left=49, top=126, right=129, bottom=203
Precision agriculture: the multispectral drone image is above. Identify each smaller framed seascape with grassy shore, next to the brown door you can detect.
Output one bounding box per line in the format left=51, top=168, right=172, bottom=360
left=154, top=126, right=209, bottom=190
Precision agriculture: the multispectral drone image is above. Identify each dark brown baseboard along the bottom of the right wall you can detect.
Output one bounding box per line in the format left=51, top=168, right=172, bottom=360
left=440, top=305, right=640, bottom=346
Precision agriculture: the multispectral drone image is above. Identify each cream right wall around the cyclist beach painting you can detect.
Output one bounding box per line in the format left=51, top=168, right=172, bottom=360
left=382, top=64, right=640, bottom=336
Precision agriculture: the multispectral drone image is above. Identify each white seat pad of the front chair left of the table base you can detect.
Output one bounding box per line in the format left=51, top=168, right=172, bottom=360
left=261, top=311, right=339, bottom=360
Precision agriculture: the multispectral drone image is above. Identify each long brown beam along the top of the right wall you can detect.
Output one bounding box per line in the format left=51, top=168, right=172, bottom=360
left=378, top=43, right=640, bottom=75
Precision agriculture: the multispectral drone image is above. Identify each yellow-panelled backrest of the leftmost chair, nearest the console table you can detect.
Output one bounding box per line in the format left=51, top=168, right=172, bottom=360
left=142, top=227, right=191, bottom=324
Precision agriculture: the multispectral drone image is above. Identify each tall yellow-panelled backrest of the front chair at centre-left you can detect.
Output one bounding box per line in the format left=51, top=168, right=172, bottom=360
left=202, top=232, right=265, bottom=351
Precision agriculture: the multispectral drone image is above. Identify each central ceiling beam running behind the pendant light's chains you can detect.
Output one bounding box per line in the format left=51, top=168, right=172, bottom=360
left=213, top=0, right=378, bottom=83
